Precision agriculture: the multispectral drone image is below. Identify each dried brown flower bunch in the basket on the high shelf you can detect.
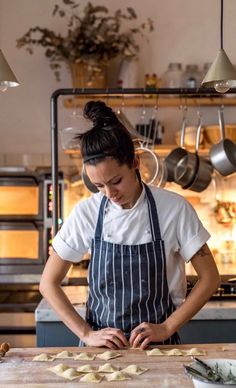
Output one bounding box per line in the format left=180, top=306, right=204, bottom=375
left=17, top=0, right=153, bottom=80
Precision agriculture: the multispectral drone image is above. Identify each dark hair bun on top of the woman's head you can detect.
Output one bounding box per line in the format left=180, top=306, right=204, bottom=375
left=84, top=101, right=119, bottom=127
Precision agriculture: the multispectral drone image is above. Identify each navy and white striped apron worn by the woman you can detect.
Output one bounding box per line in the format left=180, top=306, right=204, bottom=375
left=79, top=185, right=179, bottom=346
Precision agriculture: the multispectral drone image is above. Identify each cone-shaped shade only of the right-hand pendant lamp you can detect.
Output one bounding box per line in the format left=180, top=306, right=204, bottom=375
left=201, top=49, right=236, bottom=88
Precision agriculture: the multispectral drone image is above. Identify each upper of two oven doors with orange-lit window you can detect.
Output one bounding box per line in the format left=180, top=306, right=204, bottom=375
left=0, top=173, right=43, bottom=220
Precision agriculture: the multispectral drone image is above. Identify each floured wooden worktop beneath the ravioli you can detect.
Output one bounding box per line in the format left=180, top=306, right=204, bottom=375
left=0, top=344, right=236, bottom=388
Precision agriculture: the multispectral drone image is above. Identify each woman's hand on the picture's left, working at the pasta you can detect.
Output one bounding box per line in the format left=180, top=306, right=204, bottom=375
left=81, top=327, right=129, bottom=349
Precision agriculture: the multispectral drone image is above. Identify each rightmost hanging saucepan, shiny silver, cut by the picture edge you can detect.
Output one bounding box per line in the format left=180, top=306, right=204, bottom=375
left=210, top=106, right=236, bottom=176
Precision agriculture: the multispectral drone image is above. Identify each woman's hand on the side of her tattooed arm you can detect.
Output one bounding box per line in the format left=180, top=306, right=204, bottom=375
left=129, top=322, right=171, bottom=349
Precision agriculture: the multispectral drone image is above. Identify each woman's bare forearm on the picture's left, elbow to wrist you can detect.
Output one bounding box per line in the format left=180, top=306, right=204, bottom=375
left=40, top=284, right=91, bottom=339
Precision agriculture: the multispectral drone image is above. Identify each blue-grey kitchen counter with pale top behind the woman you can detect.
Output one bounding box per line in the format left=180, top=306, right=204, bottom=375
left=35, top=286, right=236, bottom=347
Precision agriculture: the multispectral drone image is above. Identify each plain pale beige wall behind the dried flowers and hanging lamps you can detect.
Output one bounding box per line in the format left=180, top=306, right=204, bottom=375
left=0, top=0, right=236, bottom=164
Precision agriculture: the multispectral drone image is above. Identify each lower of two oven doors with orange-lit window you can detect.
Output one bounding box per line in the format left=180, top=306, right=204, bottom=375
left=0, top=221, right=47, bottom=274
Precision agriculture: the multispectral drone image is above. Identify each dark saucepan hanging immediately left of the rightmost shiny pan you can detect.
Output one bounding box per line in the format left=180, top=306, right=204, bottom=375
left=182, top=118, right=213, bottom=193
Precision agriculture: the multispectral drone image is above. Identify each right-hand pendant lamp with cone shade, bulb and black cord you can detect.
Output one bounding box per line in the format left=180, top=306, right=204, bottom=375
left=201, top=0, right=236, bottom=93
